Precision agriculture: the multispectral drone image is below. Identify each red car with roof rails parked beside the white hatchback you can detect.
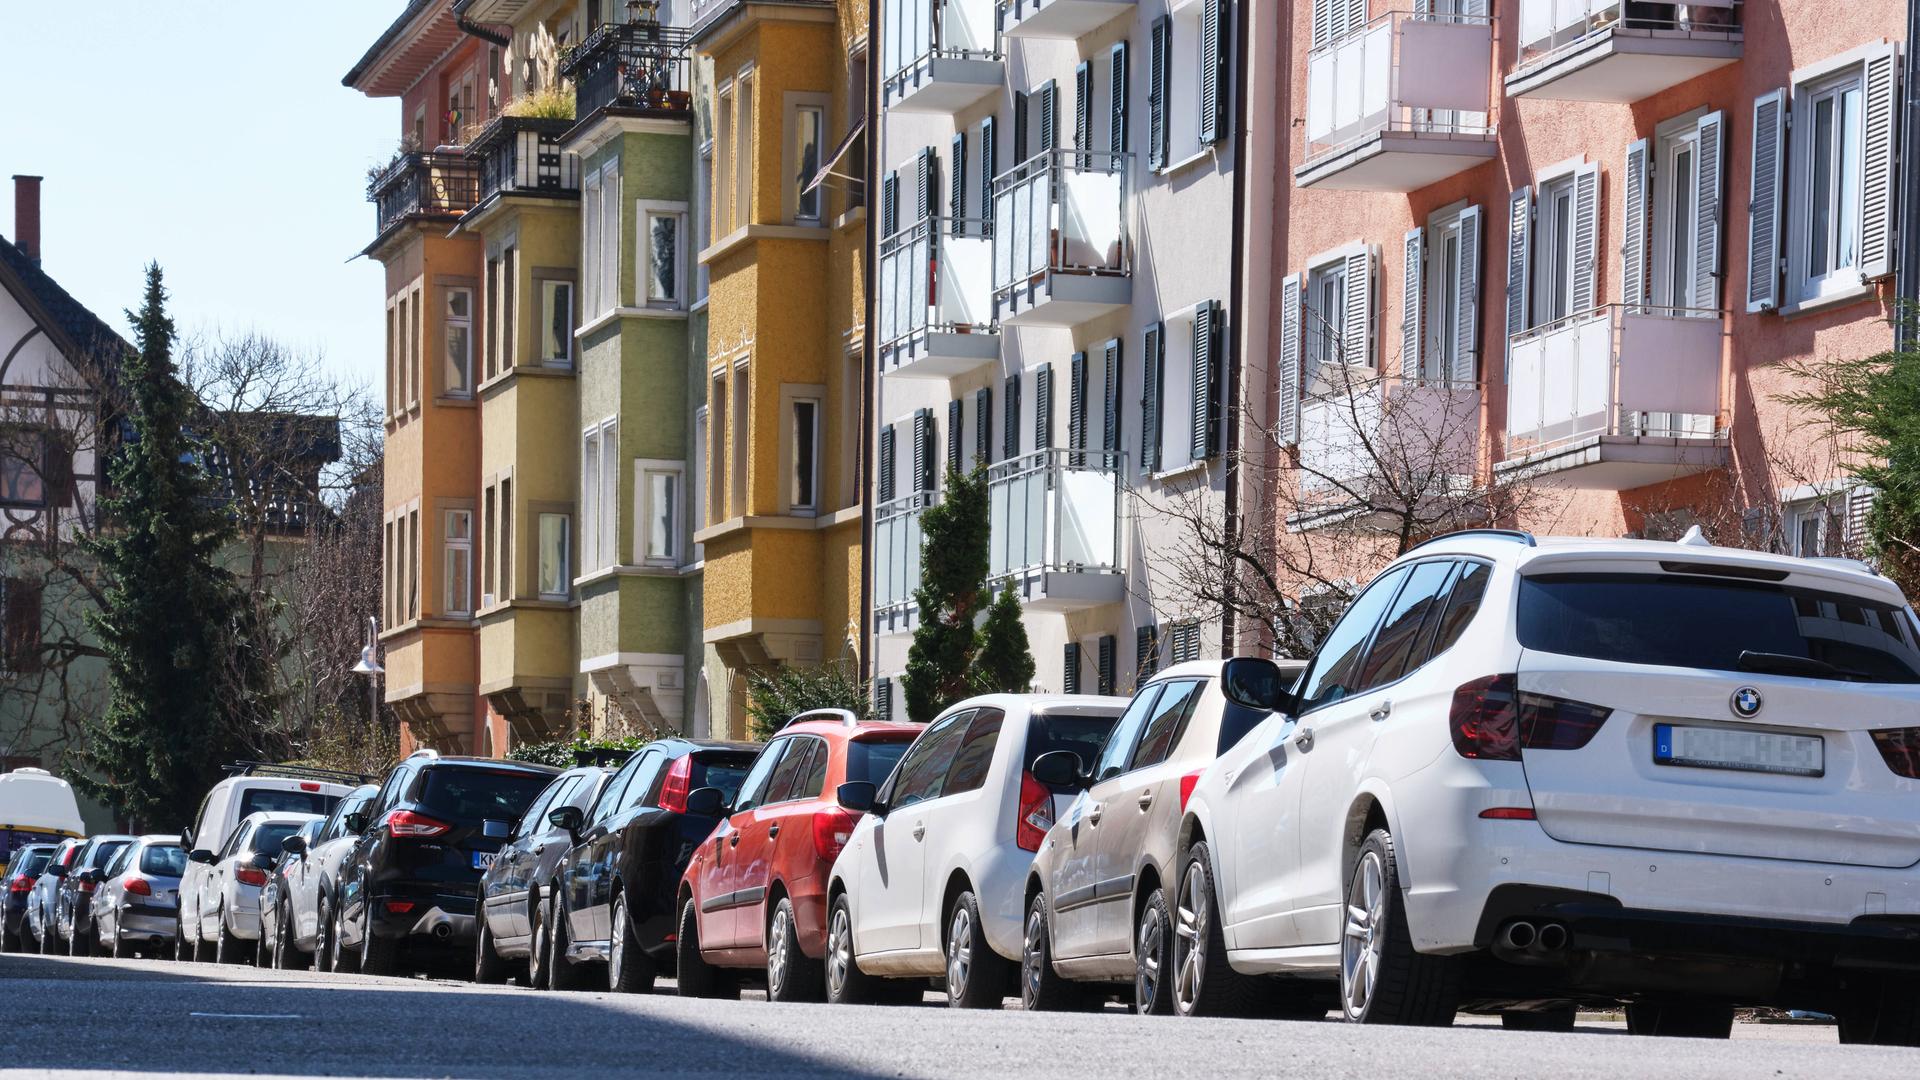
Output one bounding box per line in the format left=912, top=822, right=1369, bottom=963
left=676, top=709, right=922, bottom=1001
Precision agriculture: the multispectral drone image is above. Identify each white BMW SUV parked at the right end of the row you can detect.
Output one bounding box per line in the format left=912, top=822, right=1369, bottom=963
left=1173, top=530, right=1920, bottom=1045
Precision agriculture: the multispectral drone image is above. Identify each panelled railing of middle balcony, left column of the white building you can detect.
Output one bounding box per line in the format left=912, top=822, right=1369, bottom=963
left=879, top=217, right=993, bottom=375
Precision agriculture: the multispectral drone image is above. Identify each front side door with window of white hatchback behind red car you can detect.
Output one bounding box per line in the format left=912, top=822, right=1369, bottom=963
left=854, top=709, right=973, bottom=953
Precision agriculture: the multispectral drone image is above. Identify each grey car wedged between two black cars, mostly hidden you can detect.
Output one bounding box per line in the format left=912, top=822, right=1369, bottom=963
left=474, top=759, right=618, bottom=982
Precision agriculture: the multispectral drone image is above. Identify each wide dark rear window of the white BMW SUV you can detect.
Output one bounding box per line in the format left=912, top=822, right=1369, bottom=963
left=1519, top=575, right=1920, bottom=682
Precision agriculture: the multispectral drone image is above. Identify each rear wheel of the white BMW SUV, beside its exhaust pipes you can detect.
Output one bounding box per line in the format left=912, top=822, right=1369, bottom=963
left=1340, top=828, right=1459, bottom=1028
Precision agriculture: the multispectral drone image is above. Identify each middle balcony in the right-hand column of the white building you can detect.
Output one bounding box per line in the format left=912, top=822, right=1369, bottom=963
left=993, top=150, right=1133, bottom=327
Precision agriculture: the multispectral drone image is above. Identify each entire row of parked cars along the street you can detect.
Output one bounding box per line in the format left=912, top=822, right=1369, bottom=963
left=10, top=528, right=1920, bottom=1045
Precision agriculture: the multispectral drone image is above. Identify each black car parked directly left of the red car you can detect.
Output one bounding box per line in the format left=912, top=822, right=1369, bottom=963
left=532, top=738, right=760, bottom=992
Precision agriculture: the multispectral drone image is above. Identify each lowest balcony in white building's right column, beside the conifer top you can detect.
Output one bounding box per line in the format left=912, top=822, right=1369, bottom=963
left=987, top=450, right=1127, bottom=611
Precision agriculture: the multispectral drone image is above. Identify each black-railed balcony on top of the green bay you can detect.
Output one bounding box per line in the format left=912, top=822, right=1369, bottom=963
left=561, top=21, right=693, bottom=138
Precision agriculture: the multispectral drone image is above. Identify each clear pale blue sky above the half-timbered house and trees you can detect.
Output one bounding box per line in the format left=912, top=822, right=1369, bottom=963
left=0, top=0, right=405, bottom=382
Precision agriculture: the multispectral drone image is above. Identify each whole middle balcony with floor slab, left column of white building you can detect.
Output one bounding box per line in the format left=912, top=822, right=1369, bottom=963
left=879, top=217, right=1000, bottom=379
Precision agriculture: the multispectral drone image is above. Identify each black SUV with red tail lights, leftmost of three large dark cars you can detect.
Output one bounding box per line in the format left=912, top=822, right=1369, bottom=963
left=330, top=749, right=559, bottom=974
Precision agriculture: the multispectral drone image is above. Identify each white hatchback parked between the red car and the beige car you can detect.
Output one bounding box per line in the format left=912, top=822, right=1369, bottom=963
left=826, top=694, right=1127, bottom=1009
